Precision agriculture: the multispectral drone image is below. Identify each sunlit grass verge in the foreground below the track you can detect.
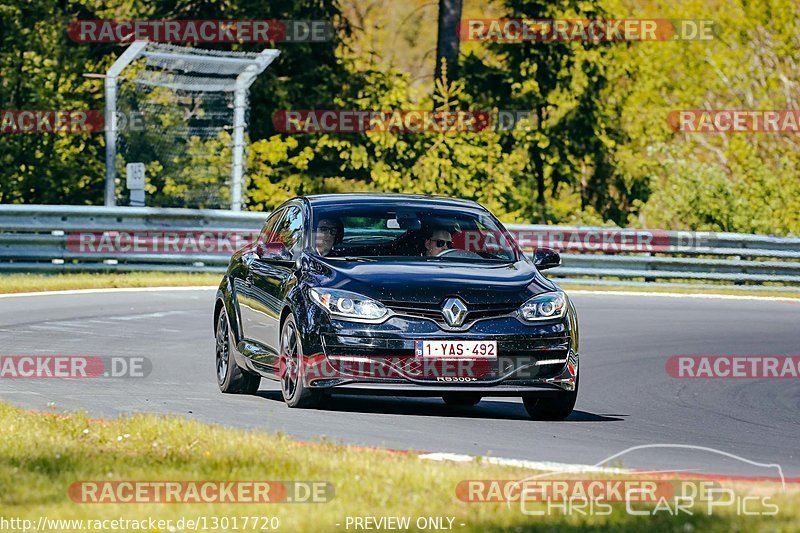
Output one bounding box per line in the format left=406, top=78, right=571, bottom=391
left=0, top=403, right=800, bottom=532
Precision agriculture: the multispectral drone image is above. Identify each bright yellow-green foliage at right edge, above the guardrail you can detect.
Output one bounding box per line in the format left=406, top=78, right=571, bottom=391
left=603, top=0, right=800, bottom=235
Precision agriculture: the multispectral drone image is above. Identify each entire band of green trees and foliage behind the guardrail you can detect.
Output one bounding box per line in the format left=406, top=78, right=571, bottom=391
left=0, top=0, right=800, bottom=235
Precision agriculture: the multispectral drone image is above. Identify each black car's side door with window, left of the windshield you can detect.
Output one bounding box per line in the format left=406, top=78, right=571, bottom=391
left=239, top=205, right=304, bottom=368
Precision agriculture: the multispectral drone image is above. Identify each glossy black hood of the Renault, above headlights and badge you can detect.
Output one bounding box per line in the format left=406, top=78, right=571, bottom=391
left=311, top=260, right=557, bottom=304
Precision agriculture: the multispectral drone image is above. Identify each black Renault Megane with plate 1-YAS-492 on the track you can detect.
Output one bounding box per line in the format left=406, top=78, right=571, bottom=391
left=214, top=194, right=580, bottom=420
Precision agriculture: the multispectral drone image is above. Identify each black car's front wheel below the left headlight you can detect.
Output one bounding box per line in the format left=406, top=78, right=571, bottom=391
left=279, top=314, right=322, bottom=409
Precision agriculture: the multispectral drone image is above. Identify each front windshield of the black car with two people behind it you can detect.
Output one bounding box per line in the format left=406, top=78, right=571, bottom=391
left=312, top=204, right=518, bottom=262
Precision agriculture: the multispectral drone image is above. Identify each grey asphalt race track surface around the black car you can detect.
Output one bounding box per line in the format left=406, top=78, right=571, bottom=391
left=0, top=289, right=800, bottom=477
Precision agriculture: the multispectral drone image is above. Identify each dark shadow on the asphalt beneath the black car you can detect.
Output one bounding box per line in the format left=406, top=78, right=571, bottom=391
left=258, top=389, right=628, bottom=422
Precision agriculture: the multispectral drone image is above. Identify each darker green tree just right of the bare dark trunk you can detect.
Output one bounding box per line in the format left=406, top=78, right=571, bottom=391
left=463, top=0, right=612, bottom=223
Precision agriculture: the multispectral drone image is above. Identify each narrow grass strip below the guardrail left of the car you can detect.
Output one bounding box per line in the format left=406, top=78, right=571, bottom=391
left=0, top=272, right=222, bottom=293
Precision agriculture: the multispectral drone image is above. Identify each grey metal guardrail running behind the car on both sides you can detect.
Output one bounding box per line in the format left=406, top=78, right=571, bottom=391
left=0, top=205, right=800, bottom=291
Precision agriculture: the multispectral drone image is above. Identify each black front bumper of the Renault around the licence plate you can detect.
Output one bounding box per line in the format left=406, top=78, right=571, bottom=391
left=304, top=317, right=579, bottom=396
